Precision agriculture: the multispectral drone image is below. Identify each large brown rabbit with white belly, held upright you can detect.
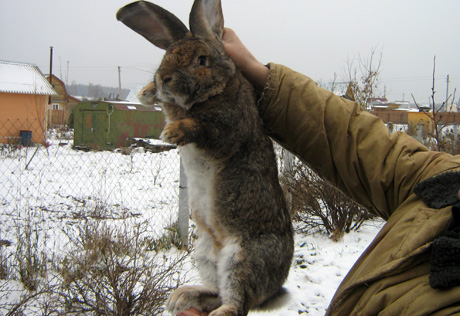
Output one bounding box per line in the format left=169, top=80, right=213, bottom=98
left=117, top=0, right=294, bottom=316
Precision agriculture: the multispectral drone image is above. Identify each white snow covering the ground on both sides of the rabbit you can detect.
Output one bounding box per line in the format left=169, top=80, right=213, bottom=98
left=0, top=135, right=383, bottom=316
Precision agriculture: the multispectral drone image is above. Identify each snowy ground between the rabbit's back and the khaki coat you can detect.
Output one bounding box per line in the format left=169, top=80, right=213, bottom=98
left=178, top=220, right=383, bottom=316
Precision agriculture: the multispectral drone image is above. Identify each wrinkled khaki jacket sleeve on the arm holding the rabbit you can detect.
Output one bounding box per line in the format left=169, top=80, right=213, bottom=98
left=259, top=64, right=459, bottom=219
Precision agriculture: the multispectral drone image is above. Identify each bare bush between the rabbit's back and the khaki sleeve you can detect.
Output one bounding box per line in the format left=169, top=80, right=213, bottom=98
left=290, top=162, right=370, bottom=241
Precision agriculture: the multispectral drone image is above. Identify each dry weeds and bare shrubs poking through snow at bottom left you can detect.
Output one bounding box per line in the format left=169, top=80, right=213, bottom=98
left=0, top=219, right=188, bottom=316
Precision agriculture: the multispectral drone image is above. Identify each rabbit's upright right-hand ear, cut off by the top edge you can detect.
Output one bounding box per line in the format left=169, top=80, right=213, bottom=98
left=190, top=0, right=224, bottom=40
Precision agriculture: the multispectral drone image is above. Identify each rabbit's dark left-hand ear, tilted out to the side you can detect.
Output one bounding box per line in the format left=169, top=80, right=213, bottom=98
left=117, top=1, right=188, bottom=49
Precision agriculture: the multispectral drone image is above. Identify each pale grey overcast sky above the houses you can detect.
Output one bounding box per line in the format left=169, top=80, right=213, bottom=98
left=0, top=0, right=460, bottom=103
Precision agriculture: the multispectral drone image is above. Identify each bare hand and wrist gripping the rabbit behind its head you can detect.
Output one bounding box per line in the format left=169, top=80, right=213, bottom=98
left=222, top=28, right=269, bottom=90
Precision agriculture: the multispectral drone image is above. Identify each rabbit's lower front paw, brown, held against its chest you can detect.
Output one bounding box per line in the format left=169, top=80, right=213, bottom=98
left=161, top=118, right=198, bottom=146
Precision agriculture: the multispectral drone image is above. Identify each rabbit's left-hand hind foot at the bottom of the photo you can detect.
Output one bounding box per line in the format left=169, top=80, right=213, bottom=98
left=166, top=285, right=220, bottom=315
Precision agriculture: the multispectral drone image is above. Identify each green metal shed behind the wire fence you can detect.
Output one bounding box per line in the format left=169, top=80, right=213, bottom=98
left=74, top=101, right=165, bottom=149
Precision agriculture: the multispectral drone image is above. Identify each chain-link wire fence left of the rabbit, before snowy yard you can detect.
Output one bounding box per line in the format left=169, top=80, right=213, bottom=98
left=0, top=121, right=180, bottom=240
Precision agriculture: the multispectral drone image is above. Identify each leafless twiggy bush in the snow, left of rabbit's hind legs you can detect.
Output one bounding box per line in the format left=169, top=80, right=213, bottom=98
left=54, top=221, right=186, bottom=316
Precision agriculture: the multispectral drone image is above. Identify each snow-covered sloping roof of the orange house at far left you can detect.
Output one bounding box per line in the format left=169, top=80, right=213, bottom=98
left=0, top=60, right=56, bottom=95
